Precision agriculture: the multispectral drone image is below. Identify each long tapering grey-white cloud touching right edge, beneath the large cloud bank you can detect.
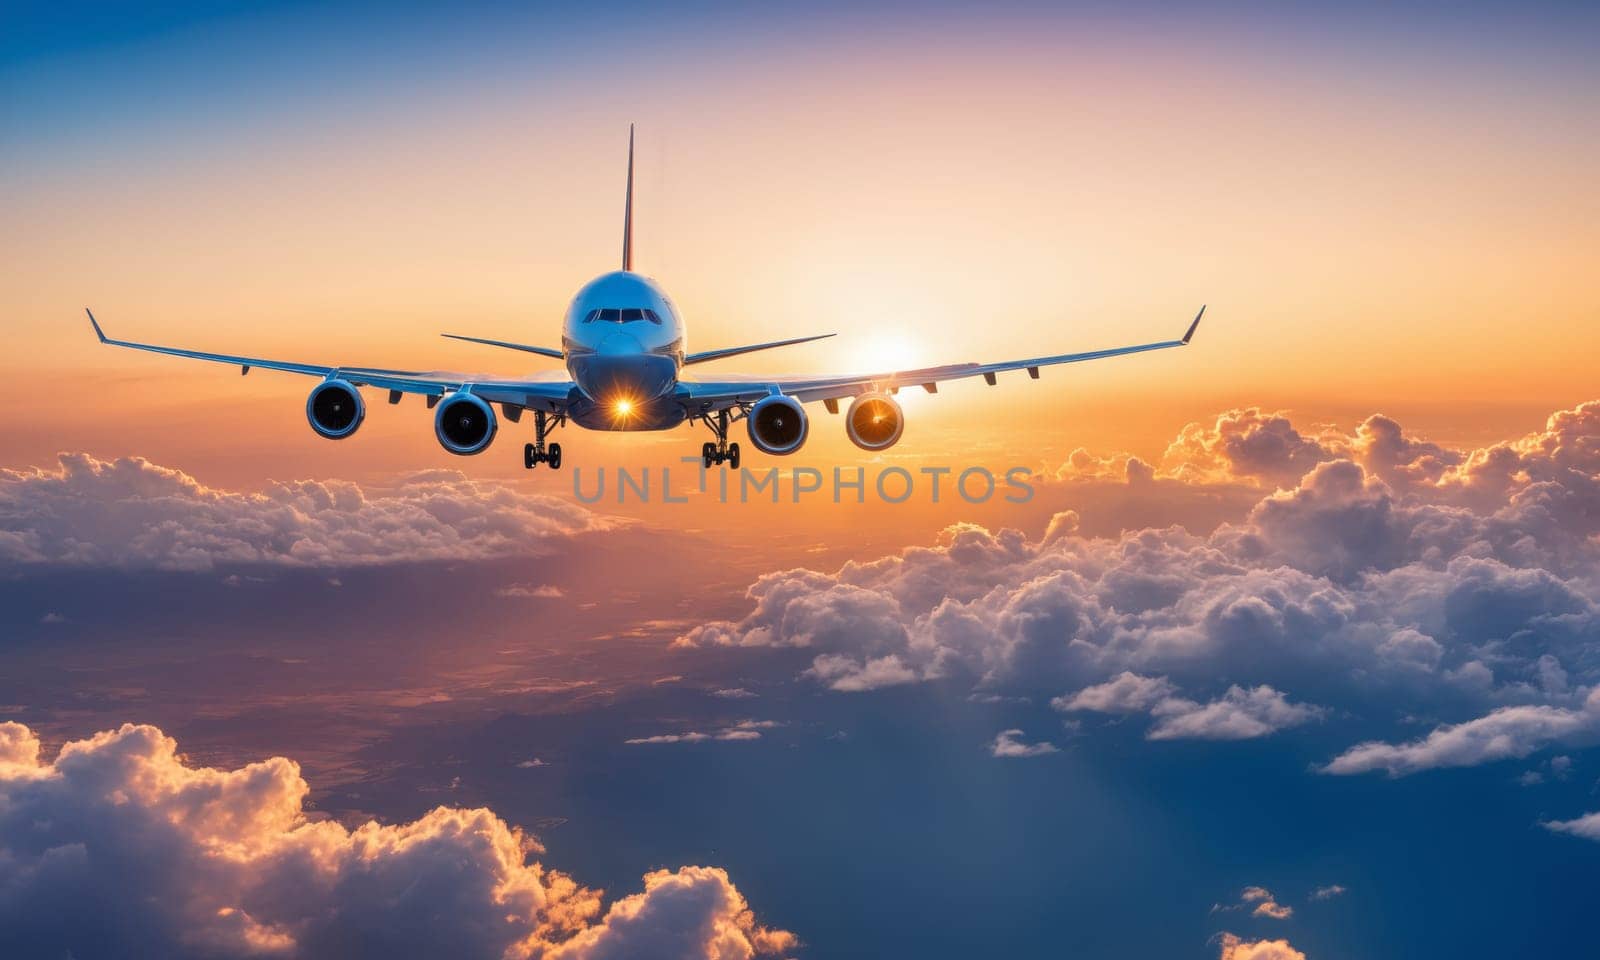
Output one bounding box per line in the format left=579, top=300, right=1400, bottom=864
left=1322, top=688, right=1600, bottom=776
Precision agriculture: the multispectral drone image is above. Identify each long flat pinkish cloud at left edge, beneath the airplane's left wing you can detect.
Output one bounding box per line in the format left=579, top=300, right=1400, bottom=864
left=0, top=453, right=619, bottom=573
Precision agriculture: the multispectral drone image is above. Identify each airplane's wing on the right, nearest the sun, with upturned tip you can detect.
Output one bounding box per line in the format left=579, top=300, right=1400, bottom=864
left=678, top=307, right=1205, bottom=414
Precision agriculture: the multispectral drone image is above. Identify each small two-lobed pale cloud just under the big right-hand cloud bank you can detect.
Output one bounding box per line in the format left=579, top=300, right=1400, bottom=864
left=1050, top=670, right=1323, bottom=739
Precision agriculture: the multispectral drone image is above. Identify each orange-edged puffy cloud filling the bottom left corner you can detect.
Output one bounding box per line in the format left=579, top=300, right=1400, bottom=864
left=0, top=723, right=795, bottom=960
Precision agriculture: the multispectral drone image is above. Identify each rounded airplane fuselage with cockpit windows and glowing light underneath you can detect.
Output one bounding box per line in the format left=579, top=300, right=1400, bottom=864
left=562, top=270, right=685, bottom=430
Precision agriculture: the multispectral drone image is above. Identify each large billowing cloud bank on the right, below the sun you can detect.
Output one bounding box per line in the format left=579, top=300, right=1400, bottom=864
left=678, top=403, right=1600, bottom=776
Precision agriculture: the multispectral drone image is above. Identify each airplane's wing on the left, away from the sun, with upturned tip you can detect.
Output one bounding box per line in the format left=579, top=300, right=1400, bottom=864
left=85, top=310, right=574, bottom=413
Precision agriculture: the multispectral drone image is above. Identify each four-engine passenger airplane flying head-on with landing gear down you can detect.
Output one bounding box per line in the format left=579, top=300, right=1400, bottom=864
left=85, top=125, right=1205, bottom=470
